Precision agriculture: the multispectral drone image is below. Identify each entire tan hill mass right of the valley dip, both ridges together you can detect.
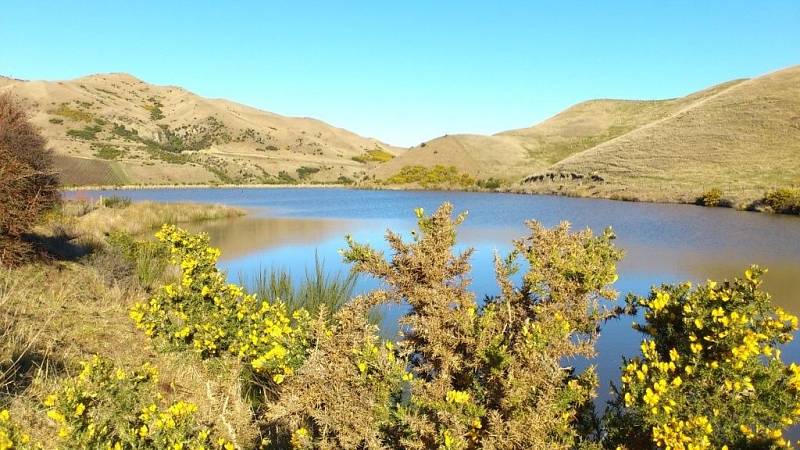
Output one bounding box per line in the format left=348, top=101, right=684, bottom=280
left=372, top=66, right=800, bottom=207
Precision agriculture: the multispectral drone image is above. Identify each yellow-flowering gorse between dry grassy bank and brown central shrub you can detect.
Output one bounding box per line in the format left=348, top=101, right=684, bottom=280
left=130, top=225, right=310, bottom=384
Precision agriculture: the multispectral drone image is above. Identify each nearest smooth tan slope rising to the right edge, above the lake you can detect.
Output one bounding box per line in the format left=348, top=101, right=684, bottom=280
left=526, top=66, right=800, bottom=201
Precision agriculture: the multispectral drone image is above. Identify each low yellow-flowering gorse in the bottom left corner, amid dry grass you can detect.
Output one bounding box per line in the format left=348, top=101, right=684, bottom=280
left=44, top=356, right=233, bottom=450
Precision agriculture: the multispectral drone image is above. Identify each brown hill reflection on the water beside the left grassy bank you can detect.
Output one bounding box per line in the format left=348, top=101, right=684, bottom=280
left=187, top=216, right=356, bottom=261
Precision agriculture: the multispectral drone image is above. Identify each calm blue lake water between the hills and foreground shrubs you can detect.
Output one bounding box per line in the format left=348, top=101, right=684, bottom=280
left=68, top=189, right=800, bottom=408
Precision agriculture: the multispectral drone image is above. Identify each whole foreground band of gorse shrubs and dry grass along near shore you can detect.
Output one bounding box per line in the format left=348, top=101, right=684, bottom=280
left=0, top=199, right=800, bottom=449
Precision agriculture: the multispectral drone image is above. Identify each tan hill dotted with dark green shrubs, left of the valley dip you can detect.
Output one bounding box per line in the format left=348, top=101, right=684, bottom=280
left=0, top=73, right=400, bottom=185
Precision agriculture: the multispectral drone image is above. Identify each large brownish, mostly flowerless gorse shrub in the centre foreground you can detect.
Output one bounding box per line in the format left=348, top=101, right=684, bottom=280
left=265, top=204, right=621, bottom=449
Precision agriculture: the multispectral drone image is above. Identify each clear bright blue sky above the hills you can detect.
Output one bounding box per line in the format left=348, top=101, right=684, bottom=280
left=0, top=0, right=800, bottom=145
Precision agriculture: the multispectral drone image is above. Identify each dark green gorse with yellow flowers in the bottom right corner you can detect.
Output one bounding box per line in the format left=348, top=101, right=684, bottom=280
left=607, top=266, right=800, bottom=449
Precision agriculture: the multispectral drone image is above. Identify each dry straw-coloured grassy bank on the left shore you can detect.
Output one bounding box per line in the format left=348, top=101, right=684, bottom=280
left=0, top=201, right=255, bottom=445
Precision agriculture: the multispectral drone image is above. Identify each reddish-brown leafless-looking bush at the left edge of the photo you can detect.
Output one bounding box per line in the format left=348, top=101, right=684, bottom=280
left=0, top=94, right=59, bottom=265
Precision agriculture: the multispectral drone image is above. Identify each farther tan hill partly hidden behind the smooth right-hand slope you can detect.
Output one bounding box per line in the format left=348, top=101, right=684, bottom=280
left=373, top=80, right=742, bottom=183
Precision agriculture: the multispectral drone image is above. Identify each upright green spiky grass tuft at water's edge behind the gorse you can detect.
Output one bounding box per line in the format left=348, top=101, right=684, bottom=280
left=239, top=253, right=358, bottom=314
